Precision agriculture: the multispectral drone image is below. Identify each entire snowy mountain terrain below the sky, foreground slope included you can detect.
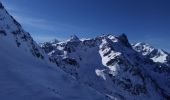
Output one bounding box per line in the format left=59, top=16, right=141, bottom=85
left=0, top=3, right=170, bottom=100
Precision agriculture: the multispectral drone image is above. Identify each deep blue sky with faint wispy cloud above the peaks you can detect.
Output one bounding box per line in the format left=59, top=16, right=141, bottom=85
left=1, top=0, right=170, bottom=51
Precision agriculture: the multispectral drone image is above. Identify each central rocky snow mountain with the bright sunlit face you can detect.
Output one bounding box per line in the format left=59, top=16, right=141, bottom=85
left=41, top=34, right=170, bottom=100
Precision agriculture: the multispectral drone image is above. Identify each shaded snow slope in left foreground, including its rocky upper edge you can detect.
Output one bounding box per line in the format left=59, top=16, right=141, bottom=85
left=0, top=3, right=107, bottom=100
